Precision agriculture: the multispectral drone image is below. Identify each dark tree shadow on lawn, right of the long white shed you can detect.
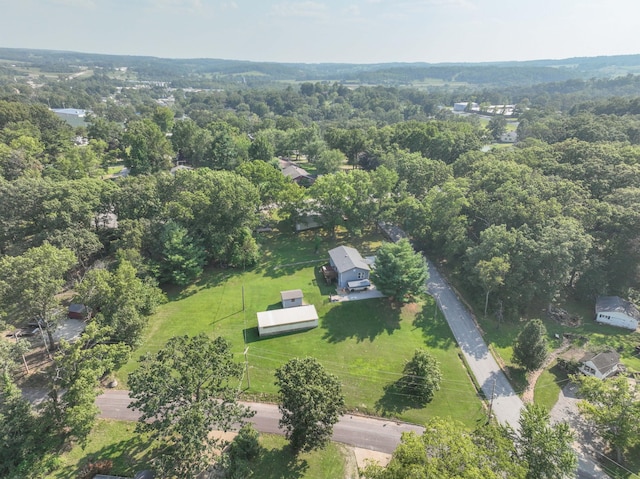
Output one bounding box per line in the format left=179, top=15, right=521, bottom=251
left=320, top=298, right=401, bottom=343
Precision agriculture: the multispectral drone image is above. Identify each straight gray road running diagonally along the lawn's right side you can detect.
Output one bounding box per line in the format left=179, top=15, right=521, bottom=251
left=427, top=260, right=524, bottom=430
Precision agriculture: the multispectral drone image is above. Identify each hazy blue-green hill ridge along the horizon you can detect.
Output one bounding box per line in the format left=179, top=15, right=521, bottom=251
left=0, top=48, right=640, bottom=87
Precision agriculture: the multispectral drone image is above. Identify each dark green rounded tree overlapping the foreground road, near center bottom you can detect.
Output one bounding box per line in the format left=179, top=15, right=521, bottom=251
left=275, top=357, right=344, bottom=452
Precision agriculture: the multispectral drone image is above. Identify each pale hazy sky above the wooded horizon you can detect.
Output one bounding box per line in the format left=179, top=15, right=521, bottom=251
left=0, top=0, right=640, bottom=63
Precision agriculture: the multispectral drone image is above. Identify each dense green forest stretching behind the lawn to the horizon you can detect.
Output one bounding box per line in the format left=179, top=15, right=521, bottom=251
left=0, top=49, right=640, bottom=477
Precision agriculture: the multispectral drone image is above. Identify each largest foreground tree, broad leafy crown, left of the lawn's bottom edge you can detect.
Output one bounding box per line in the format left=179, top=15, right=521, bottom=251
left=129, top=334, right=253, bottom=477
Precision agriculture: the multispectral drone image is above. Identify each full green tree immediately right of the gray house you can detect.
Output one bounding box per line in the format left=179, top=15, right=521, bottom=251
left=371, top=238, right=429, bottom=302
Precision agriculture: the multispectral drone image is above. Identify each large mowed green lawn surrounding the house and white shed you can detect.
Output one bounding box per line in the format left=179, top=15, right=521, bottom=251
left=118, top=228, right=484, bottom=428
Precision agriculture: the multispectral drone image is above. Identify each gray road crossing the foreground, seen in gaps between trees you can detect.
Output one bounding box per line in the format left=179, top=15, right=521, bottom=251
left=96, top=390, right=424, bottom=454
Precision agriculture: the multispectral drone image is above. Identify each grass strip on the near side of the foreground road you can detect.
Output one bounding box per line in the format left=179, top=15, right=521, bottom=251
left=48, top=420, right=347, bottom=479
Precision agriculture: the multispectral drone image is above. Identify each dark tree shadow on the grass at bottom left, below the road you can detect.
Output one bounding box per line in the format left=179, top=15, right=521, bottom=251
left=55, top=434, right=153, bottom=477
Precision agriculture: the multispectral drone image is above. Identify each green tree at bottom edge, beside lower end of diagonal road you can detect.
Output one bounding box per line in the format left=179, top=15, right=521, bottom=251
left=518, top=404, right=578, bottom=479
